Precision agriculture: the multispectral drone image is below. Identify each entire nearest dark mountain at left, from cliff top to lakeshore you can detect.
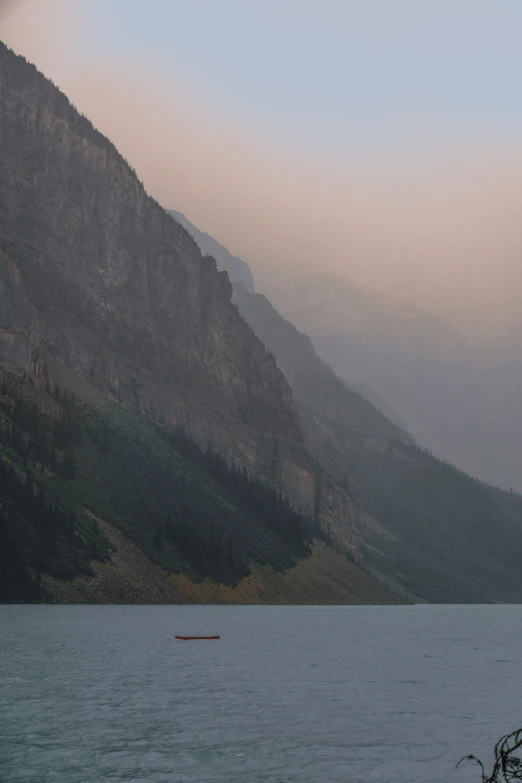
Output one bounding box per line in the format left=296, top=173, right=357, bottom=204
left=0, top=45, right=398, bottom=602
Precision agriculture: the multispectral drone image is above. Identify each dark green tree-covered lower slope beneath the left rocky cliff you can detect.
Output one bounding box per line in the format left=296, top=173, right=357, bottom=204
left=0, top=364, right=320, bottom=601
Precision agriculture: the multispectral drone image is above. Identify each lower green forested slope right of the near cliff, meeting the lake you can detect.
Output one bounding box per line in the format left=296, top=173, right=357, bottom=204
left=304, top=414, right=522, bottom=603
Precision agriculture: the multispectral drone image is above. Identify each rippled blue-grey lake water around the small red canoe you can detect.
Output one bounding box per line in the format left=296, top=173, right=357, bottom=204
left=0, top=606, right=522, bottom=783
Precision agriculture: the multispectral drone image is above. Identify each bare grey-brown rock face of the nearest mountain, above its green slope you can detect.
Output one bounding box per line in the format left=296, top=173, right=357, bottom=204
left=0, top=45, right=356, bottom=549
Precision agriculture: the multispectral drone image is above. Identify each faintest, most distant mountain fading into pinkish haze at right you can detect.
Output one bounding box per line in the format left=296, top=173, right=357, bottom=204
left=269, top=276, right=522, bottom=489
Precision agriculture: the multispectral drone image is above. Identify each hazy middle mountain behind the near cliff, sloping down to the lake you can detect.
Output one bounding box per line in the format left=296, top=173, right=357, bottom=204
left=172, top=222, right=522, bottom=603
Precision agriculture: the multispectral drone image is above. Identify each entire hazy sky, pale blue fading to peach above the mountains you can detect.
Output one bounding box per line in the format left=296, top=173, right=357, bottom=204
left=0, top=0, right=522, bottom=335
